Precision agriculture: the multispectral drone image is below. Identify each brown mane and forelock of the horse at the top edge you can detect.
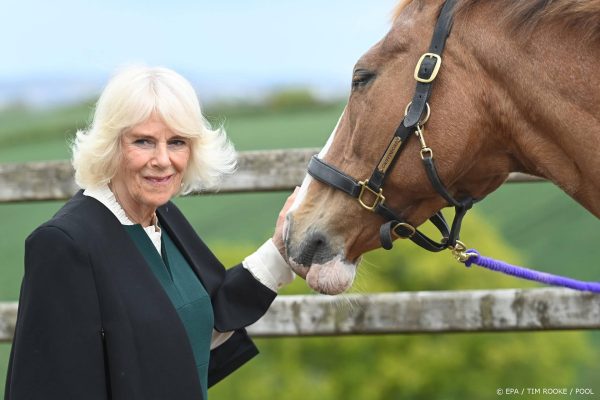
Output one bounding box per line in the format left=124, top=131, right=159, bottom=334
left=393, top=0, right=600, bottom=40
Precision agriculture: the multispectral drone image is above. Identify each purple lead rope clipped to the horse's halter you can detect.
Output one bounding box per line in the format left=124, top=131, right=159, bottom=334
left=462, top=249, right=600, bottom=293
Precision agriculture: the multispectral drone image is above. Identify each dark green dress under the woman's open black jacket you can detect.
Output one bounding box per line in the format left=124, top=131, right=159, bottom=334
left=123, top=225, right=214, bottom=400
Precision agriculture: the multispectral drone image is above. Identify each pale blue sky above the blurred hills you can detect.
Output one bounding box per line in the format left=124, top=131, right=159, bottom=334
left=0, top=0, right=397, bottom=103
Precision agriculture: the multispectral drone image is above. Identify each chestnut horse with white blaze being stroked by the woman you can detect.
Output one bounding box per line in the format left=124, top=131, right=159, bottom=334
left=284, top=0, right=600, bottom=294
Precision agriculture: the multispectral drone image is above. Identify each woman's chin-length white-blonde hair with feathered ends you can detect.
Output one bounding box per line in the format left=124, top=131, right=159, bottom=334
left=71, top=66, right=236, bottom=193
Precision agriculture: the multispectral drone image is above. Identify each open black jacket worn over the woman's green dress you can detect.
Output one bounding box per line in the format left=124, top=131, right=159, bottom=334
left=5, top=191, right=275, bottom=400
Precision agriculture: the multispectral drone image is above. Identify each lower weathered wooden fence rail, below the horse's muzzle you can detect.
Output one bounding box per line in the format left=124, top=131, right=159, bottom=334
left=0, top=288, right=600, bottom=341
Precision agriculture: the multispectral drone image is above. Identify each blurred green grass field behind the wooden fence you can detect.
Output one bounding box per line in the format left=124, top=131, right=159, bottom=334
left=0, top=104, right=600, bottom=393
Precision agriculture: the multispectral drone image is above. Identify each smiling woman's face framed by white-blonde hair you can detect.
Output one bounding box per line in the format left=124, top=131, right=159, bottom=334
left=111, top=115, right=191, bottom=223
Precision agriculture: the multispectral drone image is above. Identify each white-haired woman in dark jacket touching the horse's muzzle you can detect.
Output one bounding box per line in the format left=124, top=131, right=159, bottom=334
left=6, top=67, right=293, bottom=400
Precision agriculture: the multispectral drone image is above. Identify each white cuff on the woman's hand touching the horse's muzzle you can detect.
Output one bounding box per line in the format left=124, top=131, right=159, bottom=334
left=242, top=239, right=296, bottom=292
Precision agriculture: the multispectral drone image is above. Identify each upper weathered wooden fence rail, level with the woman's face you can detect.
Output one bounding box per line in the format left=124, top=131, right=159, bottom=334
left=0, top=149, right=542, bottom=203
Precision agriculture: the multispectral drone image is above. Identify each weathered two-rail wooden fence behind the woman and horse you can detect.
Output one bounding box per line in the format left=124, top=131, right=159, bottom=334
left=0, top=149, right=600, bottom=341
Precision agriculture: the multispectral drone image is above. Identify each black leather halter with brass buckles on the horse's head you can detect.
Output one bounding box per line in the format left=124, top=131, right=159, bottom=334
left=308, top=0, right=475, bottom=252
